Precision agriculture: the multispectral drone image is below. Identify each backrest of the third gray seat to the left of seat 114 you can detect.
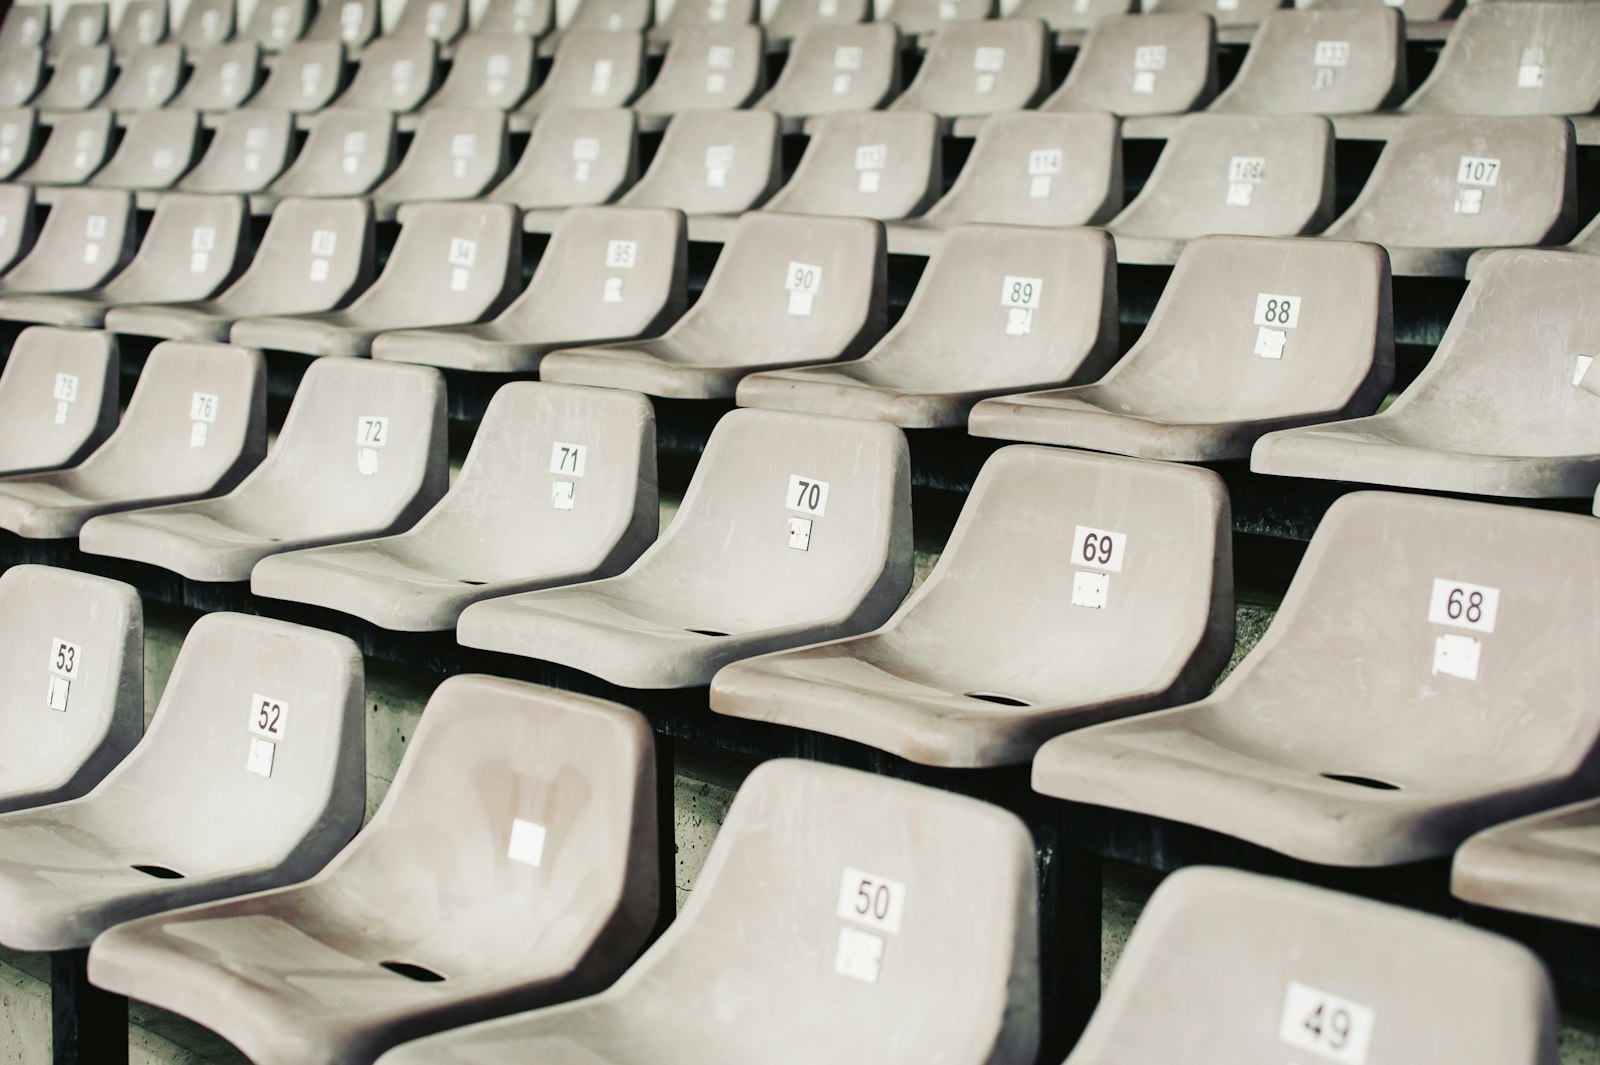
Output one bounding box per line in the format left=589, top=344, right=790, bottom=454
left=486, top=107, right=638, bottom=209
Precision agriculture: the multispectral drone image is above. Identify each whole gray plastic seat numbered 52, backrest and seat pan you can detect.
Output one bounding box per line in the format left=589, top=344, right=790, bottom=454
left=0, top=614, right=366, bottom=950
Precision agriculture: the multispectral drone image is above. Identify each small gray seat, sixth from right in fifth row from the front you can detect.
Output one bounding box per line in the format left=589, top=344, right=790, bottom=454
left=634, top=25, right=766, bottom=133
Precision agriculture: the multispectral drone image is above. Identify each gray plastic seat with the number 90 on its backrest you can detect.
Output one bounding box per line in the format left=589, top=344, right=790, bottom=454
left=539, top=211, right=888, bottom=400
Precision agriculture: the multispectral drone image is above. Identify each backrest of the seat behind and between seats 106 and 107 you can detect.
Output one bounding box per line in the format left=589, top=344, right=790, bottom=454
left=1211, top=8, right=1405, bottom=115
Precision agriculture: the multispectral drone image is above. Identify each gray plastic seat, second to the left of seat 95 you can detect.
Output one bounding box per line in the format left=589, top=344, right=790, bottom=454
left=106, top=198, right=376, bottom=342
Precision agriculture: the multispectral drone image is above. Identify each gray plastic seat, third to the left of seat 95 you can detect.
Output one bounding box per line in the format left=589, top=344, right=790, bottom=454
left=0, top=192, right=250, bottom=326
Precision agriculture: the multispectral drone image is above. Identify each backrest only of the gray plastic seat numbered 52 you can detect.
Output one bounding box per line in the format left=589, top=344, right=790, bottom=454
left=93, top=612, right=366, bottom=883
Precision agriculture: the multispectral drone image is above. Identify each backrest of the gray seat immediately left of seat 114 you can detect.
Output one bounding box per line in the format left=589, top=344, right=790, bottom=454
left=766, top=110, right=944, bottom=221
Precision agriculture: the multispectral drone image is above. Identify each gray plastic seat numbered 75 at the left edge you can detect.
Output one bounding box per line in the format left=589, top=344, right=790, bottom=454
left=0, top=326, right=122, bottom=473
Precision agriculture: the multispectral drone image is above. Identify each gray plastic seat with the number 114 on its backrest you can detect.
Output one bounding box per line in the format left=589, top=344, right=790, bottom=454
left=888, top=110, right=1122, bottom=256
